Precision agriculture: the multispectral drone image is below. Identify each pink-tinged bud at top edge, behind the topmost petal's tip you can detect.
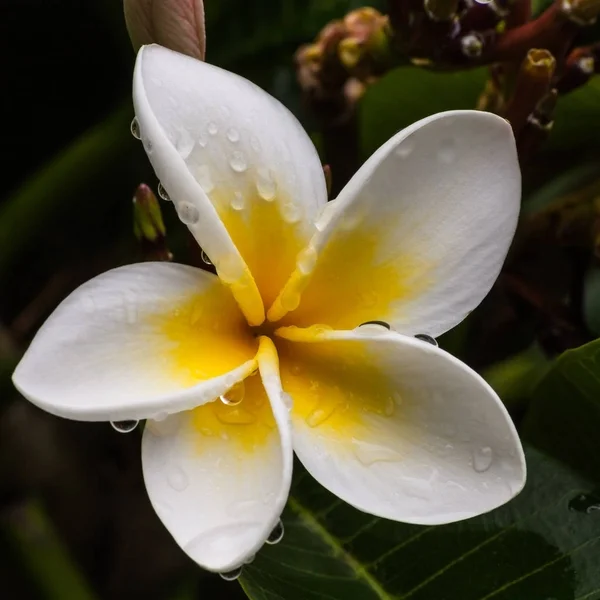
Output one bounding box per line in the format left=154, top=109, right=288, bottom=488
left=124, top=0, right=206, bottom=60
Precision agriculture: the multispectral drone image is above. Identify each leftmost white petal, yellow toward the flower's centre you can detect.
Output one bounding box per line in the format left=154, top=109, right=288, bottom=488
left=13, top=263, right=257, bottom=421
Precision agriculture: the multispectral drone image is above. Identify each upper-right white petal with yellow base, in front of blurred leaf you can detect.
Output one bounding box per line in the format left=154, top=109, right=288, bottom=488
left=268, top=111, right=521, bottom=336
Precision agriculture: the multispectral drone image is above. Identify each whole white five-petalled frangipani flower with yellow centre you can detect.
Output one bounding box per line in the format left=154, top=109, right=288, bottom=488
left=14, top=46, right=525, bottom=572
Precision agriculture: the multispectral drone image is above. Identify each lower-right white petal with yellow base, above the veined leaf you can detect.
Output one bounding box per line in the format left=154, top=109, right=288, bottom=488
left=277, top=326, right=525, bottom=525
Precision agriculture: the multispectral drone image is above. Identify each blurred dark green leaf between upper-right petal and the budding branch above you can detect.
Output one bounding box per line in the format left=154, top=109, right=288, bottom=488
left=359, top=67, right=487, bottom=157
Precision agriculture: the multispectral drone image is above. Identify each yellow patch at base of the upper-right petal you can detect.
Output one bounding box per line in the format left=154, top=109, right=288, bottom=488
left=267, top=229, right=434, bottom=329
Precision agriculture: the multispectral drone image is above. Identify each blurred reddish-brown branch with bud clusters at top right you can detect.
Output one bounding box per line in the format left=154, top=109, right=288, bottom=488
left=296, top=0, right=600, bottom=184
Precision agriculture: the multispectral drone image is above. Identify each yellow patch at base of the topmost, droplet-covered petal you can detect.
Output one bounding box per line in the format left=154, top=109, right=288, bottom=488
left=211, top=189, right=307, bottom=306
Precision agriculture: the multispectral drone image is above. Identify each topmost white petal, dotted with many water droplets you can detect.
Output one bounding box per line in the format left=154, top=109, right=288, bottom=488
left=134, top=46, right=327, bottom=312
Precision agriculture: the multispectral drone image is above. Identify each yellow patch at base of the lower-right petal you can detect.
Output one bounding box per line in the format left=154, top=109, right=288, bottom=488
left=275, top=338, right=402, bottom=442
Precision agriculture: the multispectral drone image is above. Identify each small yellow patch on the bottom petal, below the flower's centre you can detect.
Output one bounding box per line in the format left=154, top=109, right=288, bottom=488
left=192, top=375, right=277, bottom=458
